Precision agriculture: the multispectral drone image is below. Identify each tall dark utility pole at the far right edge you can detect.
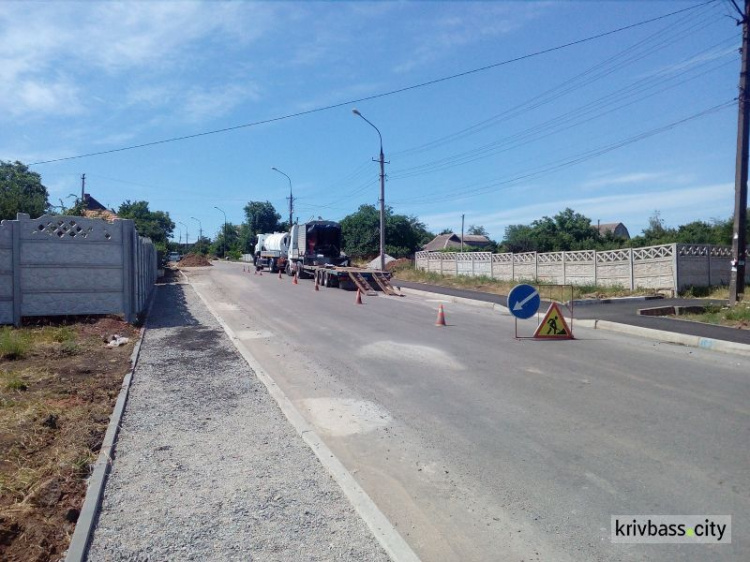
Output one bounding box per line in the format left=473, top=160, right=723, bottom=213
left=729, top=0, right=750, bottom=306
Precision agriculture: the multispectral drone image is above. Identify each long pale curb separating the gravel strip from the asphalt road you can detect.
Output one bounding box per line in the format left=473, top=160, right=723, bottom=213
left=183, top=274, right=420, bottom=562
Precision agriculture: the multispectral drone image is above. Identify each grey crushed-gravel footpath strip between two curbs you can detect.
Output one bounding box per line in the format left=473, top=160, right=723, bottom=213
left=88, top=285, right=388, bottom=562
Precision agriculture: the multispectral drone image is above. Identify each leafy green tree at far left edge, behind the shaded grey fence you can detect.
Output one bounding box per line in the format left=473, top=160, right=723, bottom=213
left=0, top=160, right=50, bottom=220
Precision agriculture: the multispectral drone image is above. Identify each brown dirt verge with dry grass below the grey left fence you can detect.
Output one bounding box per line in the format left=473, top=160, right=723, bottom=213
left=0, top=317, right=139, bottom=562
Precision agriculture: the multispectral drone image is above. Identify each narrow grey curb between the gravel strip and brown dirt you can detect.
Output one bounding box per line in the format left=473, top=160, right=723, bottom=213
left=65, top=294, right=158, bottom=562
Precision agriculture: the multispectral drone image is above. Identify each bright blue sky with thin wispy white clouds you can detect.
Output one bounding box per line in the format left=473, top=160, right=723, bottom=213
left=0, top=0, right=741, bottom=240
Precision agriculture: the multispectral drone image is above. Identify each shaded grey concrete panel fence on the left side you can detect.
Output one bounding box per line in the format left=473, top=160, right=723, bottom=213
left=0, top=213, right=157, bottom=326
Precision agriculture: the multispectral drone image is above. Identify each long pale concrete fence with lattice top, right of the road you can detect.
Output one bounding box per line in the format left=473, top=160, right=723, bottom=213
left=416, top=244, right=750, bottom=291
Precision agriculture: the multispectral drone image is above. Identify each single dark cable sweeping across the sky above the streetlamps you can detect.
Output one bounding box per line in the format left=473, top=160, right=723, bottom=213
left=29, top=0, right=716, bottom=166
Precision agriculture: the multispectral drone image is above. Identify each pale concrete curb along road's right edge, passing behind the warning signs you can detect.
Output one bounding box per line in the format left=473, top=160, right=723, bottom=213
left=400, top=287, right=750, bottom=357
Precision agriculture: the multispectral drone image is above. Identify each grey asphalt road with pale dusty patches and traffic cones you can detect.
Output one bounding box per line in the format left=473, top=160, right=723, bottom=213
left=179, top=262, right=750, bottom=562
